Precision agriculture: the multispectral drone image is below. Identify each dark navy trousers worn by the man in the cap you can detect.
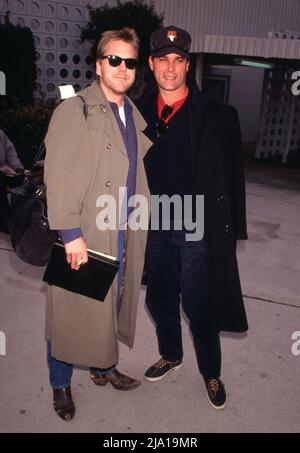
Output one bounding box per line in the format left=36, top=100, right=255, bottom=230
left=146, top=229, right=221, bottom=380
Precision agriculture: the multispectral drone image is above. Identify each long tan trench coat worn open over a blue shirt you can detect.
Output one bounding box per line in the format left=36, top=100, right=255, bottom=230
left=45, top=81, right=151, bottom=368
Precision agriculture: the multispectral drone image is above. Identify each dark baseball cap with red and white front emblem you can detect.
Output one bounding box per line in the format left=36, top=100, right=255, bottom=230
left=150, top=25, right=192, bottom=58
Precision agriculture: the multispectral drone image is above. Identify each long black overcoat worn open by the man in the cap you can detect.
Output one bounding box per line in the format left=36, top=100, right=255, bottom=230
left=139, top=85, right=248, bottom=332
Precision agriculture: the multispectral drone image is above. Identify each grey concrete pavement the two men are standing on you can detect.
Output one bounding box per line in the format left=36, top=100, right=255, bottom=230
left=0, top=163, right=300, bottom=433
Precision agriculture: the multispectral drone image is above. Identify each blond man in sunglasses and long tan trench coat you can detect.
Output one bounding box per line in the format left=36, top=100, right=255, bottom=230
left=45, top=28, right=151, bottom=420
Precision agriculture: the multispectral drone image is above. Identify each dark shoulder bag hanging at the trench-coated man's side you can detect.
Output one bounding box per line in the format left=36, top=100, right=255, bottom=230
left=9, top=144, right=57, bottom=266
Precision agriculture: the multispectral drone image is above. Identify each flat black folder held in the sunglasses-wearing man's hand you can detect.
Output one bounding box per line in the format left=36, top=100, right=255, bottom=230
left=43, top=242, right=120, bottom=302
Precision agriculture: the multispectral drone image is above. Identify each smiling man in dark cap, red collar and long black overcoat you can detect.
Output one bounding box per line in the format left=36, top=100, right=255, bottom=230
left=139, top=25, right=248, bottom=409
